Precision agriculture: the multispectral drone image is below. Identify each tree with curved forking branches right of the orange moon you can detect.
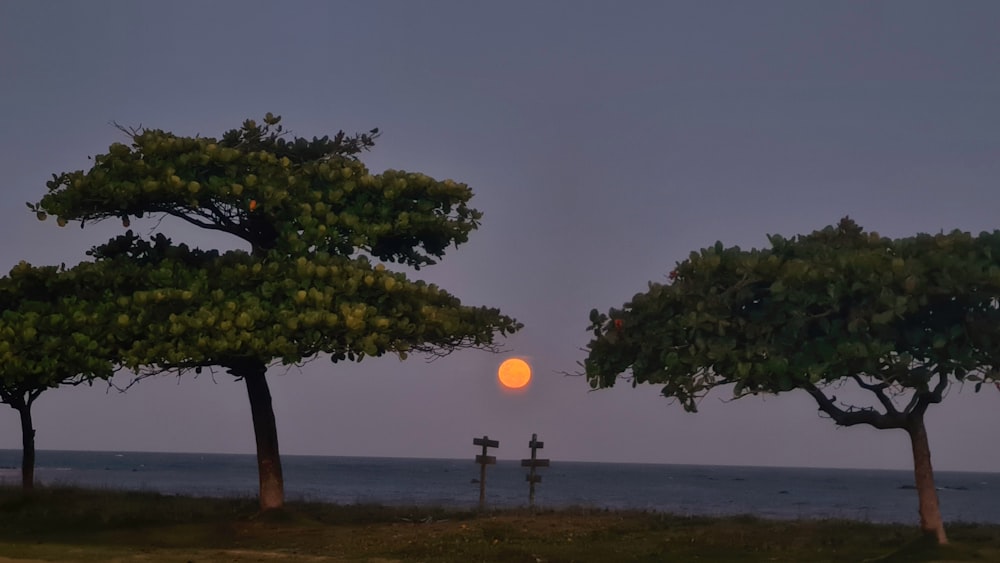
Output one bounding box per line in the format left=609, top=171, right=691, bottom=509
left=584, top=219, right=1000, bottom=543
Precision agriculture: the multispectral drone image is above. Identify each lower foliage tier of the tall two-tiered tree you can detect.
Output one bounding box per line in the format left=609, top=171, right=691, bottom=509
left=92, top=231, right=520, bottom=369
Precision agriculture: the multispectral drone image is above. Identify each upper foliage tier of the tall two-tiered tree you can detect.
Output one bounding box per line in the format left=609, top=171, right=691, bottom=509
left=28, top=114, right=482, bottom=268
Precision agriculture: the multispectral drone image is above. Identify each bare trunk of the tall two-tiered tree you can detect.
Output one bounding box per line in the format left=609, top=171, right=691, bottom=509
left=230, top=363, right=285, bottom=512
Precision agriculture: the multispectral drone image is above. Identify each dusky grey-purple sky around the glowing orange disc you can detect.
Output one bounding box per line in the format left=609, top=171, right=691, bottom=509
left=0, top=0, right=1000, bottom=472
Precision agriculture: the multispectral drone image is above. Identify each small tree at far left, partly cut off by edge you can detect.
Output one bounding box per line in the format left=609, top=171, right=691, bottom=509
left=0, top=262, right=121, bottom=490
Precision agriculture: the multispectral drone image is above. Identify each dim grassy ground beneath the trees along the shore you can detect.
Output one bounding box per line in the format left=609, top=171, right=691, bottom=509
left=0, top=487, right=1000, bottom=563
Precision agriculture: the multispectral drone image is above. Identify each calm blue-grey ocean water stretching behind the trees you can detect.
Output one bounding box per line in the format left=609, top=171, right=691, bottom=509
left=0, top=450, right=1000, bottom=523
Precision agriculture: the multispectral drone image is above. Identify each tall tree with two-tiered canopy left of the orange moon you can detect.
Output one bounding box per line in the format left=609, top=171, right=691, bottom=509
left=29, top=114, right=520, bottom=510
